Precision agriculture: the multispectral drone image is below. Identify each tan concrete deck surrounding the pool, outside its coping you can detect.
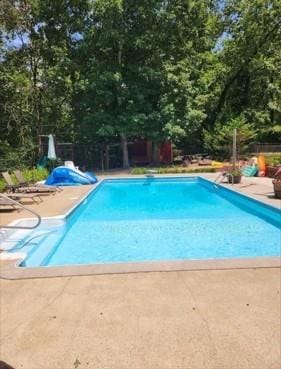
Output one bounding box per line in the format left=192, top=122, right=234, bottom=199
left=0, top=173, right=281, bottom=369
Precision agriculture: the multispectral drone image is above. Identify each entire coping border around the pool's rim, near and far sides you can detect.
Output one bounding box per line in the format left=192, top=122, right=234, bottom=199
left=0, top=174, right=281, bottom=279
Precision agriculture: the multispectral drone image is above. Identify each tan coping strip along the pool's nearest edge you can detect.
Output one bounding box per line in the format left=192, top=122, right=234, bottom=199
left=0, top=257, right=281, bottom=280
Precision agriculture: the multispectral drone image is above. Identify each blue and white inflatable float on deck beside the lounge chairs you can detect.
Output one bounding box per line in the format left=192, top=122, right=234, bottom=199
left=45, top=166, right=98, bottom=186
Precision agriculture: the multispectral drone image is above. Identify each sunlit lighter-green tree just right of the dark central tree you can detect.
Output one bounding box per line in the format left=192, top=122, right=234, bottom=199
left=161, top=0, right=220, bottom=141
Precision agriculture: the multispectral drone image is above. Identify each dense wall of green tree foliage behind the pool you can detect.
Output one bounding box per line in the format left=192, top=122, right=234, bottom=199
left=0, top=0, right=281, bottom=167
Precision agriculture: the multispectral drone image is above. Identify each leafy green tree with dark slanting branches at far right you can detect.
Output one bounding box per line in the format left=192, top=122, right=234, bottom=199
left=205, top=0, right=281, bottom=139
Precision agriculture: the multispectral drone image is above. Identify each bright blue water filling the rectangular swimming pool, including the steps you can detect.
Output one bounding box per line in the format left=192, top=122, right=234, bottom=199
left=15, top=178, right=281, bottom=267
